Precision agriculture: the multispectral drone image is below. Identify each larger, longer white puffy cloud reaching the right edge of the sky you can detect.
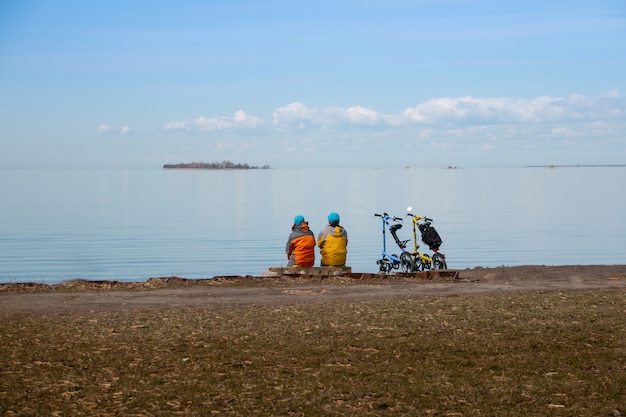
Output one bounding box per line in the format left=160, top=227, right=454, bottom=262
left=273, top=91, right=626, bottom=129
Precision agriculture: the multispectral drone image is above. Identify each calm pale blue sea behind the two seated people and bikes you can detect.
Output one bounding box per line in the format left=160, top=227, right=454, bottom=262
left=0, top=167, right=626, bottom=284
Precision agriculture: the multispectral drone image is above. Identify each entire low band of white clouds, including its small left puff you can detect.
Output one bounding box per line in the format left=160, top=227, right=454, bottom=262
left=165, top=92, right=626, bottom=133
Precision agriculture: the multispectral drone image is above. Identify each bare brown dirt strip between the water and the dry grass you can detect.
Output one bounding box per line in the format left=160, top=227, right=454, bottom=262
left=0, top=265, right=626, bottom=316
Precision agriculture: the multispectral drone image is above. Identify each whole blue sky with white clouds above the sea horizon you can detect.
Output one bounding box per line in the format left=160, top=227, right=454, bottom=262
left=0, top=0, right=626, bottom=168
